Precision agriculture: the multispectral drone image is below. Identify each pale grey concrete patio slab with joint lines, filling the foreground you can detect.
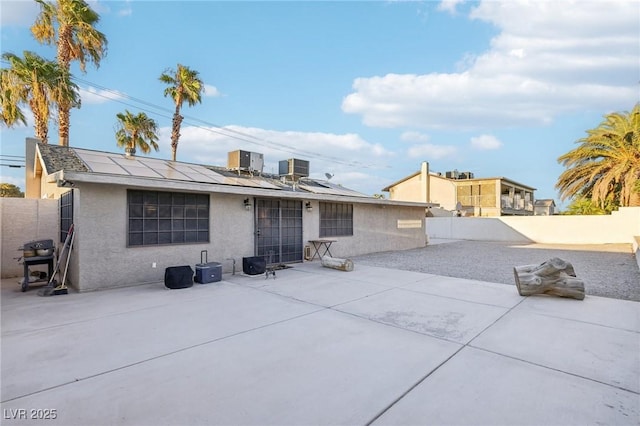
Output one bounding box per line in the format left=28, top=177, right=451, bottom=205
left=1, top=261, right=640, bottom=425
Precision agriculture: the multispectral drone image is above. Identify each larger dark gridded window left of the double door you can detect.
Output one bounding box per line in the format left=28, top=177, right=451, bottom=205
left=127, top=190, right=209, bottom=246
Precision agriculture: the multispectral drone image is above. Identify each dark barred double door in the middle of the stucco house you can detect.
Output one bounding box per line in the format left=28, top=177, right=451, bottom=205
left=254, top=199, right=303, bottom=263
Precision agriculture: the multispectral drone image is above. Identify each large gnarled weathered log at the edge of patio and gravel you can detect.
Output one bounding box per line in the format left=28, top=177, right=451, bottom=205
left=513, top=257, right=584, bottom=300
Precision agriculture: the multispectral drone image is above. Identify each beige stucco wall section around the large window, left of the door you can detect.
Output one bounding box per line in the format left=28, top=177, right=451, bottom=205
left=74, top=184, right=254, bottom=291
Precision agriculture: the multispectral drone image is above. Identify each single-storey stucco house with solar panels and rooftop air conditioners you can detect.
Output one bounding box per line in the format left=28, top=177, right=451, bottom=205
left=20, top=139, right=426, bottom=291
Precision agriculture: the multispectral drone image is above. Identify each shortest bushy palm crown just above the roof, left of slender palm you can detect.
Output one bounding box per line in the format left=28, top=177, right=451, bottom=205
left=116, top=110, right=159, bottom=155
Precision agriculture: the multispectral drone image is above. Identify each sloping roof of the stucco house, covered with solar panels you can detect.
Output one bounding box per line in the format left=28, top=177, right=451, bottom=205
left=36, top=143, right=424, bottom=204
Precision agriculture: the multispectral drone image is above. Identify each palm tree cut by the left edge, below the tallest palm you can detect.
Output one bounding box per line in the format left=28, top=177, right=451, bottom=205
left=0, top=51, right=80, bottom=143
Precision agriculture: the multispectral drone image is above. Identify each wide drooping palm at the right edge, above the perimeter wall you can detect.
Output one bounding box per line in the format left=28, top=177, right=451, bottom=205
left=556, top=103, right=640, bottom=208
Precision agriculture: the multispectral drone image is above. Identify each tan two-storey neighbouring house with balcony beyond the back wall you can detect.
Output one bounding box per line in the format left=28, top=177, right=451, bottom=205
left=383, top=161, right=535, bottom=216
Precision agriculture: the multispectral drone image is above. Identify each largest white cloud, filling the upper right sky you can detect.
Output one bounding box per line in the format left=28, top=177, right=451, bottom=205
left=342, top=1, right=640, bottom=129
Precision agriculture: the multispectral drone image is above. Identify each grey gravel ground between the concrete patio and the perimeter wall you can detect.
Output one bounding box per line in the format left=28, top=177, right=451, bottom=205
left=352, top=241, right=640, bottom=301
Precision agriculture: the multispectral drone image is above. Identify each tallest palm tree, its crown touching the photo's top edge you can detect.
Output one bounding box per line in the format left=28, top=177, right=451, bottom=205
left=31, top=0, right=107, bottom=146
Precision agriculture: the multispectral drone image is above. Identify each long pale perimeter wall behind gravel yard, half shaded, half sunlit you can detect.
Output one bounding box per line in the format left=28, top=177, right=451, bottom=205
left=426, top=207, right=640, bottom=244
